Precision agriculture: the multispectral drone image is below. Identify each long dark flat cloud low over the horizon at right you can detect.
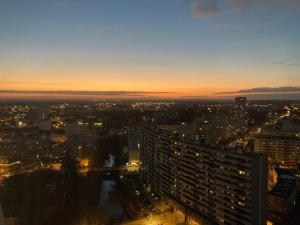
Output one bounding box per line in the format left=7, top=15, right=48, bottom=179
left=216, top=87, right=300, bottom=95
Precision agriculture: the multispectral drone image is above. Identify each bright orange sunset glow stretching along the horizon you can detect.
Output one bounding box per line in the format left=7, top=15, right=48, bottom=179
left=0, top=68, right=295, bottom=100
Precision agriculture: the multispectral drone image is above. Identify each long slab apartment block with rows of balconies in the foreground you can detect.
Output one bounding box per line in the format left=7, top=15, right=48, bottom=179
left=142, top=128, right=268, bottom=225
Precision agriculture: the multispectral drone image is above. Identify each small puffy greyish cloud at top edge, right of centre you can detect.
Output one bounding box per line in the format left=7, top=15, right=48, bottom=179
left=193, top=0, right=220, bottom=17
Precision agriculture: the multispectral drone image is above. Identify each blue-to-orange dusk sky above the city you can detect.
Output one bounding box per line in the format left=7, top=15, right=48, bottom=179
left=0, top=0, right=300, bottom=99
